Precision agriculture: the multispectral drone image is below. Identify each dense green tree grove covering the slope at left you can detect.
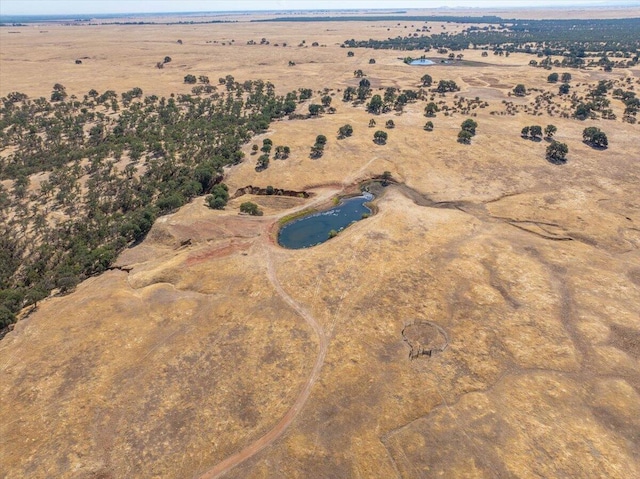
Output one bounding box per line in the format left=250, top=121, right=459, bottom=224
left=0, top=76, right=296, bottom=327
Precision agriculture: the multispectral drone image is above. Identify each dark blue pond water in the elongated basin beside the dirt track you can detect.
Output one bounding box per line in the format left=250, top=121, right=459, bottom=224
left=278, top=193, right=373, bottom=249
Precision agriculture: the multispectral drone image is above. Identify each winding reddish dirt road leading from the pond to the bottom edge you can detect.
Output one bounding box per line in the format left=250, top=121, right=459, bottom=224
left=200, top=227, right=328, bottom=479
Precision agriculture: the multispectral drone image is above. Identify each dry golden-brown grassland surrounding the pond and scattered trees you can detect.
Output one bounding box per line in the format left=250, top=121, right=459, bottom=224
left=0, top=10, right=640, bottom=478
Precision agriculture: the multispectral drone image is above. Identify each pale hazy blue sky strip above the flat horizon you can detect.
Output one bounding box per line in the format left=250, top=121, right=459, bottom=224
left=0, top=0, right=640, bottom=15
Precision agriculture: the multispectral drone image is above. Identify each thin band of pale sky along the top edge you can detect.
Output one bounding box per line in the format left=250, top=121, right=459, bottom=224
left=0, top=0, right=640, bottom=17
